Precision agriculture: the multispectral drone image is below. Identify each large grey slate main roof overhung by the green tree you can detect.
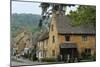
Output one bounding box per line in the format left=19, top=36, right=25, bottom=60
left=56, top=16, right=96, bottom=34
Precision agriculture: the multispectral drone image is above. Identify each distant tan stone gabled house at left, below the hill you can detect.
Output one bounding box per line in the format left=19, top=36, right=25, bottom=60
left=14, top=31, right=32, bottom=54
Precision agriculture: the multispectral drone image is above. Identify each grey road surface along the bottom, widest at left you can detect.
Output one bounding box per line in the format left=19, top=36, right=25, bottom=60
left=11, top=57, right=62, bottom=66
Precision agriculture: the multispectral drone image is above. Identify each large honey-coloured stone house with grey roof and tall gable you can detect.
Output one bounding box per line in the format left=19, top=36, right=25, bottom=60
left=37, top=14, right=96, bottom=59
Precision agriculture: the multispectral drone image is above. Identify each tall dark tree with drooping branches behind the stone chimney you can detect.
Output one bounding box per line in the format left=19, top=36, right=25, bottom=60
left=40, top=3, right=75, bottom=30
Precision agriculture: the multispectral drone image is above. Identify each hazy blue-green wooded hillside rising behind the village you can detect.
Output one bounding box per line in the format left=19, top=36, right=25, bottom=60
left=11, top=14, right=41, bottom=36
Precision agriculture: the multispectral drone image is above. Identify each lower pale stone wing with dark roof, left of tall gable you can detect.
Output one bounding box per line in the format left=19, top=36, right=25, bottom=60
left=36, top=32, right=48, bottom=59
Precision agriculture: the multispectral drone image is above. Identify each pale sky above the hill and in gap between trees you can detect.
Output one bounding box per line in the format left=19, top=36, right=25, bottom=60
left=12, top=1, right=77, bottom=15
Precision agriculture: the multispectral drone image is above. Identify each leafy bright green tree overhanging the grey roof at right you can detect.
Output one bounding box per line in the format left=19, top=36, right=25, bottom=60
left=70, top=5, right=96, bottom=27
